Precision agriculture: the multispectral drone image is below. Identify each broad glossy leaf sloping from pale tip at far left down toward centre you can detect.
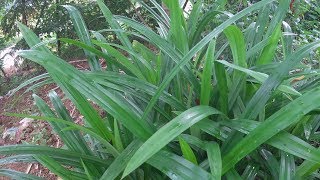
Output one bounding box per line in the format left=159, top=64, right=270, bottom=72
left=19, top=50, right=154, bottom=139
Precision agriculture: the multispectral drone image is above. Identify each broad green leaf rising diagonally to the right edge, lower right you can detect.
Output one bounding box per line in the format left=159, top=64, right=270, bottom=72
left=223, top=88, right=320, bottom=173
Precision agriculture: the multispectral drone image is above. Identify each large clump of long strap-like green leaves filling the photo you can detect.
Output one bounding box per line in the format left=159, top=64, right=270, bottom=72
left=0, top=0, right=320, bottom=179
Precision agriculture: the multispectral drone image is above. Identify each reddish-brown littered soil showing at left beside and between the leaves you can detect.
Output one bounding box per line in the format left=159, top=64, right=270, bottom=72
left=0, top=60, right=94, bottom=180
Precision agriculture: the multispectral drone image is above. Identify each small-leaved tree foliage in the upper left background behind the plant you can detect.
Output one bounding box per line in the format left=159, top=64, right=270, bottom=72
left=0, top=0, right=133, bottom=58
